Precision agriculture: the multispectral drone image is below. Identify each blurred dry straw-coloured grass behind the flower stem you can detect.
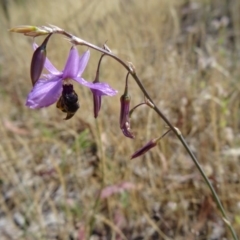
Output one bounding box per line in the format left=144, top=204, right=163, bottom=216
left=0, top=0, right=240, bottom=240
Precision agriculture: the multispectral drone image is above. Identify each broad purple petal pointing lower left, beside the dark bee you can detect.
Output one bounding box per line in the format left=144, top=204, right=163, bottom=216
left=26, top=76, right=62, bottom=108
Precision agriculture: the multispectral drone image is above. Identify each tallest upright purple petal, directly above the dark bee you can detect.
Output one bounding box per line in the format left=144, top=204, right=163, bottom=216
left=63, top=47, right=79, bottom=79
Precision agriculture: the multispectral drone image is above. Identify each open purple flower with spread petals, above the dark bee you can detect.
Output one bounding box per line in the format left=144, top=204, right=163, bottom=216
left=26, top=44, right=117, bottom=108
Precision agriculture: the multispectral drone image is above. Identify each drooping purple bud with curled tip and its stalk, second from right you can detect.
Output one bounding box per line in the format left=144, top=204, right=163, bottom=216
left=119, top=72, right=134, bottom=138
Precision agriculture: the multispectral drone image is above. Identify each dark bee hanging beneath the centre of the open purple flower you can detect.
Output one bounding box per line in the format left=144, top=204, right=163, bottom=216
left=56, top=84, right=80, bottom=120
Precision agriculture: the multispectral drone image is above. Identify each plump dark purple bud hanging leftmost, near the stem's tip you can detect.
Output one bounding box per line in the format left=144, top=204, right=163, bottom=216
left=30, top=34, right=52, bottom=86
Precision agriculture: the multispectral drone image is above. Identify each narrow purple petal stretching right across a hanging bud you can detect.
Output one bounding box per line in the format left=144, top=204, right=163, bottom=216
left=73, top=77, right=118, bottom=96
